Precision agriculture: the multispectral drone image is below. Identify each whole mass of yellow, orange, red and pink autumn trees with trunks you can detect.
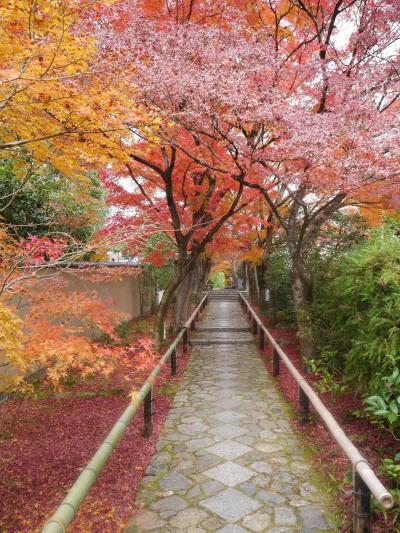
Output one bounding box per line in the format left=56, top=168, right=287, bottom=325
left=0, top=0, right=400, bottom=528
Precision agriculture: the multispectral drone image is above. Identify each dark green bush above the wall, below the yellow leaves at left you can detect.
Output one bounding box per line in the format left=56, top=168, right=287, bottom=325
left=0, top=159, right=107, bottom=242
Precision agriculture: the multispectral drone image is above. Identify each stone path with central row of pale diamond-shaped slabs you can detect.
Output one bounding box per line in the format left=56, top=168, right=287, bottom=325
left=125, top=301, right=337, bottom=533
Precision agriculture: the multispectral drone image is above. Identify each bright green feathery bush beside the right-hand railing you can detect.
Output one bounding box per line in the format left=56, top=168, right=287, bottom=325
left=314, top=227, right=400, bottom=395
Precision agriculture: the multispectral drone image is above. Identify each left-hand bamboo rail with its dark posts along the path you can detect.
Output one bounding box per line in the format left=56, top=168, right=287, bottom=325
left=42, top=294, right=208, bottom=533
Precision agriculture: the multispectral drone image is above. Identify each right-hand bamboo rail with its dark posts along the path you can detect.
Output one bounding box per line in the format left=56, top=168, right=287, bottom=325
left=239, top=292, right=394, bottom=533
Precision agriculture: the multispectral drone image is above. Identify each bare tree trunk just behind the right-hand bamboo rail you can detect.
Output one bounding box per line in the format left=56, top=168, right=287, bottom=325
left=292, top=265, right=314, bottom=371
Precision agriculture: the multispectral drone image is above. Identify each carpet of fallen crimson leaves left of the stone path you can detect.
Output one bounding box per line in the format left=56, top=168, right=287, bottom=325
left=0, top=341, right=189, bottom=533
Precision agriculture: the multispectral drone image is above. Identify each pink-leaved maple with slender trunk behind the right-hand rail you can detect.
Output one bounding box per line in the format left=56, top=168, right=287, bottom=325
left=146, top=2, right=398, bottom=357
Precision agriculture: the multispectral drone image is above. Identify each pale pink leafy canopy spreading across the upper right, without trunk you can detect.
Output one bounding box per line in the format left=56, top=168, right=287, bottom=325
left=90, top=0, right=400, bottom=206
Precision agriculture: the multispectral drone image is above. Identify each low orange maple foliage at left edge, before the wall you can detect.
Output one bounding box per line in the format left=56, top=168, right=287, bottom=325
left=0, top=222, right=119, bottom=393
